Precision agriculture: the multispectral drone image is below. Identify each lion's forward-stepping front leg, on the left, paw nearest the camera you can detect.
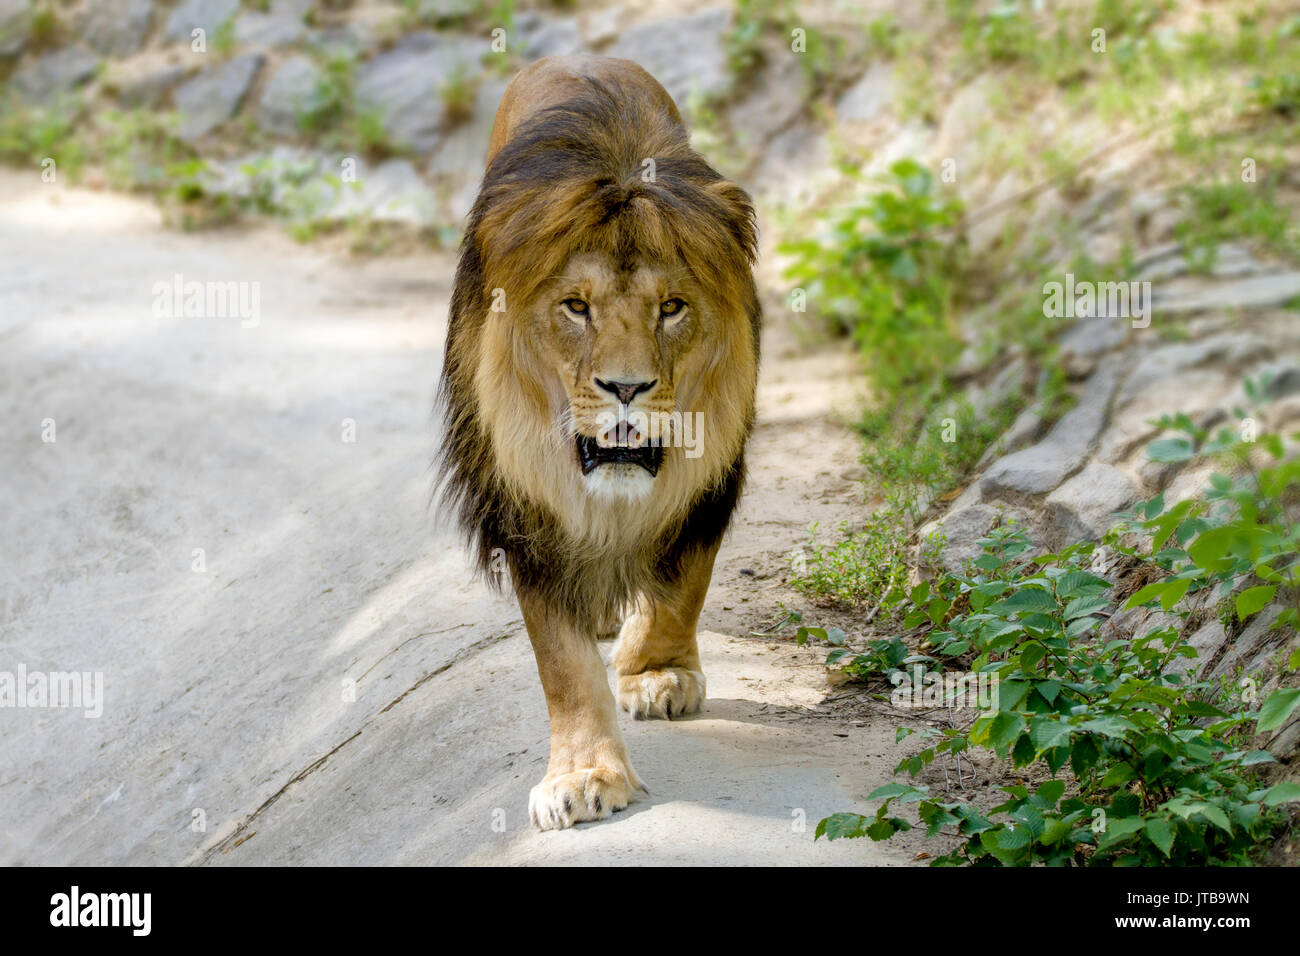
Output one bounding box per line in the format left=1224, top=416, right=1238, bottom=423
left=519, top=594, right=644, bottom=830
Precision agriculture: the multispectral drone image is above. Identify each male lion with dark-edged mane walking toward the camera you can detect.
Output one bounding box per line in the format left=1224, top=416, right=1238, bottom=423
left=441, top=56, right=759, bottom=830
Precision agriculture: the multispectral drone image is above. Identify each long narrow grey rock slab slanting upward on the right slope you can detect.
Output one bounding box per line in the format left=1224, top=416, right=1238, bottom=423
left=980, top=363, right=1121, bottom=501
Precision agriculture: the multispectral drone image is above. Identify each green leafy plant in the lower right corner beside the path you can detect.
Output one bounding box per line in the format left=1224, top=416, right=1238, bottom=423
left=816, top=400, right=1300, bottom=866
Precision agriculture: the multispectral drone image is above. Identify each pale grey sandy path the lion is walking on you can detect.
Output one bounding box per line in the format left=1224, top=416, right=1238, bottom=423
left=0, top=173, right=915, bottom=865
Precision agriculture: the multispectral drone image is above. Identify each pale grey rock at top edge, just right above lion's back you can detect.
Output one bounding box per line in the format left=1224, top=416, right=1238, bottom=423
left=608, top=8, right=732, bottom=111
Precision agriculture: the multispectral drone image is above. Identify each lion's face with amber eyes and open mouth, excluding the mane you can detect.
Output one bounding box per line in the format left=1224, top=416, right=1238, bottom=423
left=532, top=252, right=712, bottom=501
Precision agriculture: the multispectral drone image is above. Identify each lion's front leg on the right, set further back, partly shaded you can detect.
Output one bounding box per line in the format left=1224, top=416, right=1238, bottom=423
left=611, top=545, right=718, bottom=721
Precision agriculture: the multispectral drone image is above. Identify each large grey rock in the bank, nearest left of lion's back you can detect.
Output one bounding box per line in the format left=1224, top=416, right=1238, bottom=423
left=356, top=33, right=481, bottom=155
